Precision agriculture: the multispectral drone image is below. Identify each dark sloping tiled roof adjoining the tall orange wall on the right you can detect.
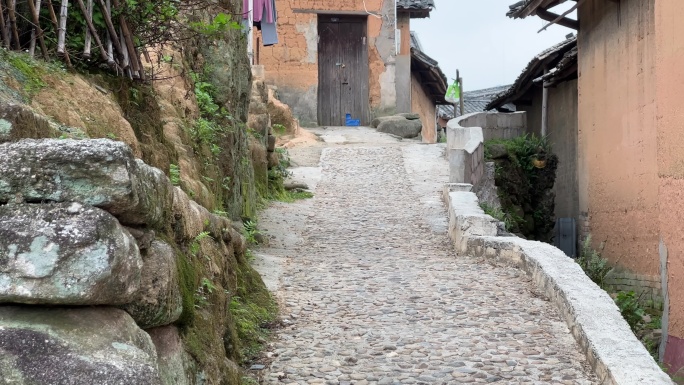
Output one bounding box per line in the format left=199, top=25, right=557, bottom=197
left=486, top=36, right=577, bottom=110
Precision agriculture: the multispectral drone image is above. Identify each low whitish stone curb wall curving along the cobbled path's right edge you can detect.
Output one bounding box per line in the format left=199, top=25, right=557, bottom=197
left=445, top=185, right=673, bottom=385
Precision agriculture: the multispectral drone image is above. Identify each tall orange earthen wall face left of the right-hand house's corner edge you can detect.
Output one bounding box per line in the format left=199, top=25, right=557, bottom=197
left=578, top=0, right=664, bottom=276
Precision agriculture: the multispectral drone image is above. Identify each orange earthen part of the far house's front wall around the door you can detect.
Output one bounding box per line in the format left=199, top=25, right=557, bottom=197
left=254, top=0, right=394, bottom=124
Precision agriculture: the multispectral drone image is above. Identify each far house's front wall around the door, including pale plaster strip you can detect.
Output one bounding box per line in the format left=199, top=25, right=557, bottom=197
left=255, top=0, right=396, bottom=126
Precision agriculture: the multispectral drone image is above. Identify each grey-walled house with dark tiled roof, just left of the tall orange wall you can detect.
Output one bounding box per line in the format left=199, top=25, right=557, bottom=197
left=486, top=36, right=580, bottom=222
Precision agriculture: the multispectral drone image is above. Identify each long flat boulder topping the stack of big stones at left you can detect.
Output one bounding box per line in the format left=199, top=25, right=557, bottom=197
left=0, top=139, right=172, bottom=226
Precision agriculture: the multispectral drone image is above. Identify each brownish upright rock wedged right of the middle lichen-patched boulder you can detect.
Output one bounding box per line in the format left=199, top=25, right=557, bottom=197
left=124, top=240, right=183, bottom=329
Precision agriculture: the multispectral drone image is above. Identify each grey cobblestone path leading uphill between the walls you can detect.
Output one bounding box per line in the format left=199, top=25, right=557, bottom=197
left=263, top=146, right=597, bottom=385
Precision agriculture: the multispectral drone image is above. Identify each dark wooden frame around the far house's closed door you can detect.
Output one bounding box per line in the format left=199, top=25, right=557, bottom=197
left=316, top=12, right=371, bottom=125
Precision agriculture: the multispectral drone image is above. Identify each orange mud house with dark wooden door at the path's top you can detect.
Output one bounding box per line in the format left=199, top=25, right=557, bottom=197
left=254, top=0, right=434, bottom=130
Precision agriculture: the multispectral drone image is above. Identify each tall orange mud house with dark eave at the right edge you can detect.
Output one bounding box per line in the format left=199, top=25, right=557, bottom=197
left=509, top=0, right=684, bottom=373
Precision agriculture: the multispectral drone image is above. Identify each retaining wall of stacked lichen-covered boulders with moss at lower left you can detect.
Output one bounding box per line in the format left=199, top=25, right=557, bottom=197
left=0, top=139, right=256, bottom=385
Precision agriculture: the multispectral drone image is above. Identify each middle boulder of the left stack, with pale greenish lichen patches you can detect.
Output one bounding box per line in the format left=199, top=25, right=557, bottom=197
left=0, top=203, right=143, bottom=305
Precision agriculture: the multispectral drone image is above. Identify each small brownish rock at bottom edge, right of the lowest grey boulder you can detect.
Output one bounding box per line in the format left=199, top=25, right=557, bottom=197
left=147, top=326, right=194, bottom=385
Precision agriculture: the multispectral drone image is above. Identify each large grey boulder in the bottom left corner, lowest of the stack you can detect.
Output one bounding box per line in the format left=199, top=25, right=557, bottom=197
left=0, top=306, right=161, bottom=385
